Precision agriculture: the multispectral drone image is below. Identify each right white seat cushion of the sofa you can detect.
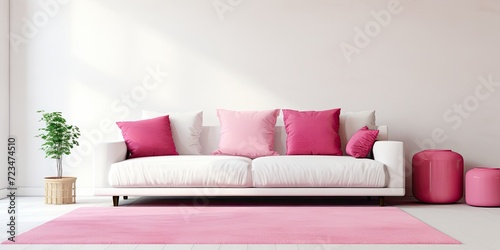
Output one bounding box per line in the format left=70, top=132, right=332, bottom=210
left=252, top=155, right=388, bottom=187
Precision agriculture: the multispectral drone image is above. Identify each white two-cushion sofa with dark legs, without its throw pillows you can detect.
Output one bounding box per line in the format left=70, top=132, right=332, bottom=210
left=93, top=123, right=405, bottom=206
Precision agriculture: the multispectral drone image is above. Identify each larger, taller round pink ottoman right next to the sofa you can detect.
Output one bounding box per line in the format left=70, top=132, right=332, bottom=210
left=412, top=149, right=464, bottom=203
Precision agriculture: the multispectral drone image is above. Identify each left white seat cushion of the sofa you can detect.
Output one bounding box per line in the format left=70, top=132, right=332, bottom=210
left=108, top=155, right=252, bottom=187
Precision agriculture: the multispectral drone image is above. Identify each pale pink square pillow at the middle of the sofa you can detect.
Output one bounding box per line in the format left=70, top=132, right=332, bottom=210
left=212, top=109, right=280, bottom=158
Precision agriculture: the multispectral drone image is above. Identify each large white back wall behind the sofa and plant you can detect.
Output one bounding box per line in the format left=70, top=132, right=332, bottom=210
left=11, top=0, right=500, bottom=194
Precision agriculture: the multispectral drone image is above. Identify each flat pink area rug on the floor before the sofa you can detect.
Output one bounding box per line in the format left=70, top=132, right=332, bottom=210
left=4, top=206, right=460, bottom=244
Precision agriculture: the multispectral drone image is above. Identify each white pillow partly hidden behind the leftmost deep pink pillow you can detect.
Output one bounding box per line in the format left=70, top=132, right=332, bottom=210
left=142, top=110, right=203, bottom=155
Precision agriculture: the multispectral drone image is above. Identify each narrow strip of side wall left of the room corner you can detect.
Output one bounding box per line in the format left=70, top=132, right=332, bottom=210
left=0, top=0, right=9, bottom=198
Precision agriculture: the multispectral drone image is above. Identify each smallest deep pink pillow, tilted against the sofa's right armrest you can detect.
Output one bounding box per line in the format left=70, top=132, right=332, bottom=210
left=346, top=126, right=379, bottom=158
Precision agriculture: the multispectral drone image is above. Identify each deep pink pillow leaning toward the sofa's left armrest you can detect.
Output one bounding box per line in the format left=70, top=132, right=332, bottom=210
left=116, top=115, right=178, bottom=158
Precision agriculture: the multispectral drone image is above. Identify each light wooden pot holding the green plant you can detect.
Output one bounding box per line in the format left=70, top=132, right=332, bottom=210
left=45, top=177, right=76, bottom=205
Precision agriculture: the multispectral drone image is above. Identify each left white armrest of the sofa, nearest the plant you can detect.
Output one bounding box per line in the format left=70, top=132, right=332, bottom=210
left=93, top=141, right=127, bottom=188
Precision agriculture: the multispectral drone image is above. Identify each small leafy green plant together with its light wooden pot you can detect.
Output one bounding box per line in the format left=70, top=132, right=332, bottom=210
left=35, top=110, right=80, bottom=204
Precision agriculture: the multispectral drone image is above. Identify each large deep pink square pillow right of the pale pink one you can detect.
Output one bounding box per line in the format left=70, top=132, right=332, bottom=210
left=283, top=108, right=342, bottom=155
